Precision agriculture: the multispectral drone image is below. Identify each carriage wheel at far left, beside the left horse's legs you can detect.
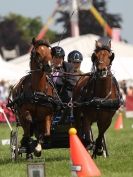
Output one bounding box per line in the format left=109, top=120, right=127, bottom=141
left=10, top=131, right=18, bottom=160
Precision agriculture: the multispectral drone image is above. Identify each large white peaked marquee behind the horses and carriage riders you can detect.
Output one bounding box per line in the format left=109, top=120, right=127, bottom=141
left=8, top=34, right=133, bottom=80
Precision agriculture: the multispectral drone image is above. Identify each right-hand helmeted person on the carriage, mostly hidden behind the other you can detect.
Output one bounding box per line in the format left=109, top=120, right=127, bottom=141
left=67, top=50, right=83, bottom=81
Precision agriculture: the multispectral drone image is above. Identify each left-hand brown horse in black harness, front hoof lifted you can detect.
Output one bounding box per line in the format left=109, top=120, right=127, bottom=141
left=8, top=39, right=54, bottom=158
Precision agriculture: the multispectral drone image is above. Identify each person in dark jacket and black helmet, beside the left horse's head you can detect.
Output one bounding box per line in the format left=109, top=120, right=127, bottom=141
left=51, top=46, right=76, bottom=103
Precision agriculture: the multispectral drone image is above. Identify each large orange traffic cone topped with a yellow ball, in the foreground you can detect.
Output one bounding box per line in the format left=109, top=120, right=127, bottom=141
left=69, top=128, right=101, bottom=177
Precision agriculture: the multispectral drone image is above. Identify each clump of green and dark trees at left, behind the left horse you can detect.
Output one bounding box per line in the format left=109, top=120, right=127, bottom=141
left=0, top=13, right=56, bottom=58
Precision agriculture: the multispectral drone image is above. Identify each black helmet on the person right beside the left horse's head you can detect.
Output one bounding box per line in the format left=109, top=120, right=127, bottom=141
left=51, top=46, right=65, bottom=58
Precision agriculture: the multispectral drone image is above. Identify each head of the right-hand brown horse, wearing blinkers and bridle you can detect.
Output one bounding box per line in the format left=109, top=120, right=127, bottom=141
left=91, top=37, right=114, bottom=77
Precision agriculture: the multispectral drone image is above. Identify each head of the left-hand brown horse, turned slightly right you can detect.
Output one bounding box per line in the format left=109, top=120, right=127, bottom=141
left=30, top=38, right=52, bottom=72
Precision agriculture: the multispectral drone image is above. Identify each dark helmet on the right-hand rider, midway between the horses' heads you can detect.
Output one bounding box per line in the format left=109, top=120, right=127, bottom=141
left=67, top=50, right=83, bottom=63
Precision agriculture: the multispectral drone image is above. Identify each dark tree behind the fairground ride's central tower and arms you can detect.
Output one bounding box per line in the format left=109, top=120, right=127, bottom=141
left=56, top=0, right=122, bottom=38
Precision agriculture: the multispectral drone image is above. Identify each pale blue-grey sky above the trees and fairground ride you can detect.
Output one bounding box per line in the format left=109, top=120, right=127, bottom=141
left=0, top=0, right=133, bottom=44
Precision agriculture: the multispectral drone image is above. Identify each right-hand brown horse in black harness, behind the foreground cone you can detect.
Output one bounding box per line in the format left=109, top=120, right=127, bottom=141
left=73, top=38, right=121, bottom=157
